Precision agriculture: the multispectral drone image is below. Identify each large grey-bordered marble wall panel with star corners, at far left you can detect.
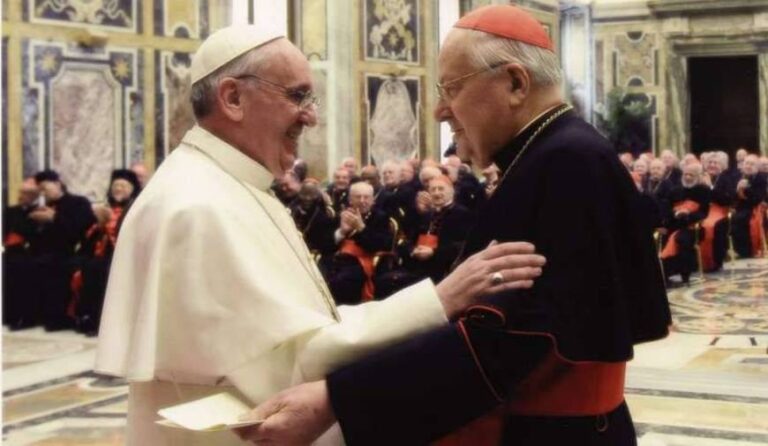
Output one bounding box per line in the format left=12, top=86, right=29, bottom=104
left=22, top=40, right=144, bottom=200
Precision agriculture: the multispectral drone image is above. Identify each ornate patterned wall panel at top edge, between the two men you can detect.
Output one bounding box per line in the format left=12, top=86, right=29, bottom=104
left=362, top=0, right=421, bottom=65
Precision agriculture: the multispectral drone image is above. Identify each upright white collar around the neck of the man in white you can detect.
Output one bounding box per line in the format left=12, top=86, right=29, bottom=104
left=182, top=125, right=274, bottom=192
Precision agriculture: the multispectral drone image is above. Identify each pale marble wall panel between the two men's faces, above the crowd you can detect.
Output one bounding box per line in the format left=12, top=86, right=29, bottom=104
left=362, top=74, right=421, bottom=164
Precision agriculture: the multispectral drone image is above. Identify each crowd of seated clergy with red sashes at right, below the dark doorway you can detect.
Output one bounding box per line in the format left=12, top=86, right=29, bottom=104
left=619, top=148, right=768, bottom=284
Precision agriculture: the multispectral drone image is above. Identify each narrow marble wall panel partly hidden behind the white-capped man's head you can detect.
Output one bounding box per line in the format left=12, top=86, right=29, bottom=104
left=155, top=51, right=195, bottom=163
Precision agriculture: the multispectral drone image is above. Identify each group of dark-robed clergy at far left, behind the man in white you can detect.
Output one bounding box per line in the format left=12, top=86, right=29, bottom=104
left=3, top=163, right=149, bottom=336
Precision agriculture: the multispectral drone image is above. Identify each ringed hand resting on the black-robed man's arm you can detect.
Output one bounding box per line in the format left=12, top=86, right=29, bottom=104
left=437, top=242, right=546, bottom=319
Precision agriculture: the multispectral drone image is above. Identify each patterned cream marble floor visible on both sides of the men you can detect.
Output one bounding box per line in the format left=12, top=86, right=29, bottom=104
left=2, top=259, right=768, bottom=446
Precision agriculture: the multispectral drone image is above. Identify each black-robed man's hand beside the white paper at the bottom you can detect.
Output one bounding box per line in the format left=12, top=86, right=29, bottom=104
left=235, top=381, right=336, bottom=446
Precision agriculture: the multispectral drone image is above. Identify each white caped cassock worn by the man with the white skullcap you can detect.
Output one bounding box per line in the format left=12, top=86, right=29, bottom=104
left=96, top=127, right=446, bottom=446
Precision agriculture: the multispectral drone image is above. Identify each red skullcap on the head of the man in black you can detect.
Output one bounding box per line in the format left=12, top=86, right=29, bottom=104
left=453, top=5, right=555, bottom=51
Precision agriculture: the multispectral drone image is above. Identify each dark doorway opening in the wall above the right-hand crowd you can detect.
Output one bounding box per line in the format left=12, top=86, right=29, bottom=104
left=688, top=56, right=760, bottom=158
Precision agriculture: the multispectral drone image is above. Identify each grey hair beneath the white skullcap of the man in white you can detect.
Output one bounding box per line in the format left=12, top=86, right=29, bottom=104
left=189, top=39, right=282, bottom=120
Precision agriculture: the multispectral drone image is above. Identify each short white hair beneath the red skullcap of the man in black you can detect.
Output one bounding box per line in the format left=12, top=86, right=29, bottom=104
left=452, top=28, right=563, bottom=86
